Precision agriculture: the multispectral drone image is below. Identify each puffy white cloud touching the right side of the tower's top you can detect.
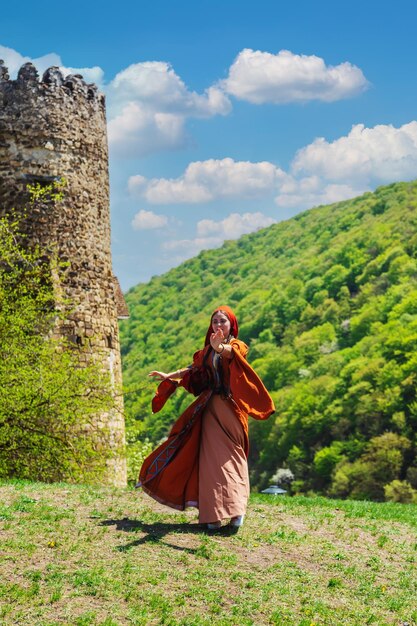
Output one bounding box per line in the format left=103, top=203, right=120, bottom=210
left=106, top=61, right=231, bottom=156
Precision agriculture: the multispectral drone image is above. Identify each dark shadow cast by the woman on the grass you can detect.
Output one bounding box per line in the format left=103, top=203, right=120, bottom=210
left=100, top=517, right=236, bottom=554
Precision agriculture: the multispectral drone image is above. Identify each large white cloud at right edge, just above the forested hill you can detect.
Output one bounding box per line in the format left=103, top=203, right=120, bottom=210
left=292, top=121, right=417, bottom=186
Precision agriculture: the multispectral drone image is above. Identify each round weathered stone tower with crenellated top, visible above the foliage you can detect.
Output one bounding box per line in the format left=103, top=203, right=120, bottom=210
left=0, top=61, right=126, bottom=485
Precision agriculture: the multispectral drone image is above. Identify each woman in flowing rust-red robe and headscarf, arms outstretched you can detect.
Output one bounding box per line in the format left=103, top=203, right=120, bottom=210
left=138, top=306, right=275, bottom=530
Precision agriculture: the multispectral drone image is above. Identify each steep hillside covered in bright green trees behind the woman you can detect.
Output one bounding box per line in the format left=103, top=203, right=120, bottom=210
left=121, top=182, right=417, bottom=501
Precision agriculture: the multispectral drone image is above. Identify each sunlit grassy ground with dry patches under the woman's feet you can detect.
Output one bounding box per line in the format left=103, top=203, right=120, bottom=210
left=0, top=482, right=417, bottom=626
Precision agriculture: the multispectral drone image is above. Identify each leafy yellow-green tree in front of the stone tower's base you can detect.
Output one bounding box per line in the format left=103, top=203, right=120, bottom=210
left=0, top=189, right=112, bottom=481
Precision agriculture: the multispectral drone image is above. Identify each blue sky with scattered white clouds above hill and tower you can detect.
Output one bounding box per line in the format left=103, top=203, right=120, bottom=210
left=0, top=0, right=417, bottom=290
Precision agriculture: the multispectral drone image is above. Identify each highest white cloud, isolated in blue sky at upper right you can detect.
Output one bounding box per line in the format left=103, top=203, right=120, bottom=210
left=220, top=49, right=368, bottom=104
